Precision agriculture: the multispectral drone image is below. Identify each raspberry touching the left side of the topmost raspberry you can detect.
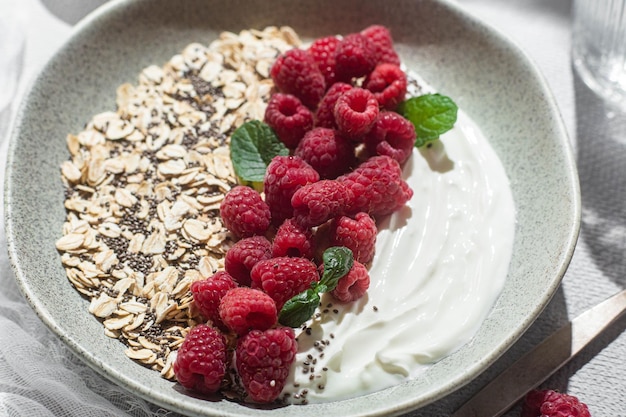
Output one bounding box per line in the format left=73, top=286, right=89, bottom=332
left=335, top=33, right=376, bottom=83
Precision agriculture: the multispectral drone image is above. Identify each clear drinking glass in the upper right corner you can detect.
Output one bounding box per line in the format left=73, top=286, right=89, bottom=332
left=572, top=0, right=626, bottom=110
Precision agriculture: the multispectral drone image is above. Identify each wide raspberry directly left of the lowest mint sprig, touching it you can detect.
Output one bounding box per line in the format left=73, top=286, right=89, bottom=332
left=250, top=256, right=320, bottom=311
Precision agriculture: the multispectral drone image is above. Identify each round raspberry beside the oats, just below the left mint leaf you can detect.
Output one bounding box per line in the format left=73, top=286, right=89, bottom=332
left=220, top=185, right=270, bottom=238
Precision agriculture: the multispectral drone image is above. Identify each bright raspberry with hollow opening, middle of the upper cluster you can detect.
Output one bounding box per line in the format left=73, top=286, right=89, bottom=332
left=334, top=87, right=378, bottom=140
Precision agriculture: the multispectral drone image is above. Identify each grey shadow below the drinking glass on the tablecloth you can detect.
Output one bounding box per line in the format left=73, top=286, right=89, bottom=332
left=574, top=68, right=626, bottom=286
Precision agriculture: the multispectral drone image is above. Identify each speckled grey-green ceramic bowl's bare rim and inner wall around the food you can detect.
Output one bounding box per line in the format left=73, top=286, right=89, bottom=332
left=5, top=0, right=580, bottom=417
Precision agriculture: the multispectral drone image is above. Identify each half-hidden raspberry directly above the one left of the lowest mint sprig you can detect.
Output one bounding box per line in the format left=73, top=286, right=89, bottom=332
left=272, top=219, right=315, bottom=259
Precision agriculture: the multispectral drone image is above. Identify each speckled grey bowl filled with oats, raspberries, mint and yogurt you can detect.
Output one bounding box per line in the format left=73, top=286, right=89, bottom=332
left=5, top=0, right=580, bottom=416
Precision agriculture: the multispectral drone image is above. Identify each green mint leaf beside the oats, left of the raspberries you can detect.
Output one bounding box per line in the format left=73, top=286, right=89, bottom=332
left=230, top=120, right=289, bottom=184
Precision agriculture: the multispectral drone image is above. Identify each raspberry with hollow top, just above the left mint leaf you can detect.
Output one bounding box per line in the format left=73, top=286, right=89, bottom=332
left=265, top=93, right=313, bottom=149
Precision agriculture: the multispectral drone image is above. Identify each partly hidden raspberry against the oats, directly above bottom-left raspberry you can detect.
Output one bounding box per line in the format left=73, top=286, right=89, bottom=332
left=191, top=271, right=237, bottom=330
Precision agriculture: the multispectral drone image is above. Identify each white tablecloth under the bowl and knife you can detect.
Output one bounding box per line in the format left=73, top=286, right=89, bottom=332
left=0, top=0, right=626, bottom=417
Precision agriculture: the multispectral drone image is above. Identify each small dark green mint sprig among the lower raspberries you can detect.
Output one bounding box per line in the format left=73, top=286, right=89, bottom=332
left=278, top=246, right=354, bottom=327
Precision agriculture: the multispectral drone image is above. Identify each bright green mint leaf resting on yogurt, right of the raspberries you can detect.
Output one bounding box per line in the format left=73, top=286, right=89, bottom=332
left=398, top=94, right=459, bottom=148
